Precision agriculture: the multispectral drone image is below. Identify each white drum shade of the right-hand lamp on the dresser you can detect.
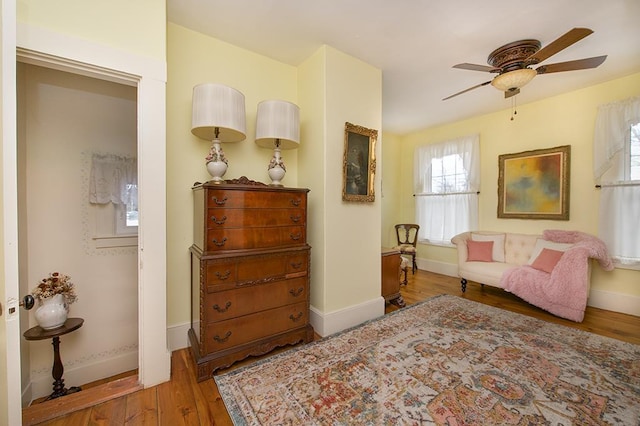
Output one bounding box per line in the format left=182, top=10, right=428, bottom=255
left=256, top=101, right=300, bottom=149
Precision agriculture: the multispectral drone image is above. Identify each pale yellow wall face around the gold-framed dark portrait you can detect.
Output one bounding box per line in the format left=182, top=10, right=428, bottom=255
left=320, top=47, right=382, bottom=312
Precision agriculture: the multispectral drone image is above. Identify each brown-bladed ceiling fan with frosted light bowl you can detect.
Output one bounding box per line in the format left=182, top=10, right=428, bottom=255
left=443, top=28, right=607, bottom=101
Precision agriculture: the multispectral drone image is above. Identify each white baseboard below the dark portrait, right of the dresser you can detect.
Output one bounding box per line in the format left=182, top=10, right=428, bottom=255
left=309, top=296, right=385, bottom=337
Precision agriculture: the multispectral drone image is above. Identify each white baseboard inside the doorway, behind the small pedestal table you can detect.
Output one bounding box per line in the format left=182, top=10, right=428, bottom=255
left=28, top=349, right=138, bottom=403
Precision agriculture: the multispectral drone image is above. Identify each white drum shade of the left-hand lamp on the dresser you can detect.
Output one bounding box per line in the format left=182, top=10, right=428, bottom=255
left=191, top=83, right=247, bottom=142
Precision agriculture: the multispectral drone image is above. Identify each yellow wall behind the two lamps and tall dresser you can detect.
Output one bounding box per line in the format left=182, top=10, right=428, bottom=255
left=167, top=23, right=307, bottom=326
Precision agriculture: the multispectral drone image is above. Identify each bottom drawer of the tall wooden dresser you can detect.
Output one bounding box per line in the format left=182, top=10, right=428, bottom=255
left=202, top=302, right=309, bottom=353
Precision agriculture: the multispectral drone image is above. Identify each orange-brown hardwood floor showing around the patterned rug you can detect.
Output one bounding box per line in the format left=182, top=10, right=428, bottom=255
left=23, top=271, right=640, bottom=426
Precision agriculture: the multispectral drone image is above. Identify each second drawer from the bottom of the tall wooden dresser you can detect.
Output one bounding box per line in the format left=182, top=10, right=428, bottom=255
left=203, top=277, right=308, bottom=322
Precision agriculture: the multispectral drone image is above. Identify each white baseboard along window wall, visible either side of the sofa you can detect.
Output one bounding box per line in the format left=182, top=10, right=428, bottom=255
left=416, top=255, right=640, bottom=316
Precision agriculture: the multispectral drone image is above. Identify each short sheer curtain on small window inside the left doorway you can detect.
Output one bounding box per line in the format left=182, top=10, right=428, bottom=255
left=89, top=154, right=138, bottom=206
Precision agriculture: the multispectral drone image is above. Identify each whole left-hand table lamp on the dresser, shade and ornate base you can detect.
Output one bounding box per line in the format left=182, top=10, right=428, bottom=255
left=191, top=83, right=246, bottom=184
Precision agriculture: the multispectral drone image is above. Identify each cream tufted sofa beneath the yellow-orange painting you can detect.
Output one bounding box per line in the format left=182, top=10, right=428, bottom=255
left=451, top=231, right=542, bottom=292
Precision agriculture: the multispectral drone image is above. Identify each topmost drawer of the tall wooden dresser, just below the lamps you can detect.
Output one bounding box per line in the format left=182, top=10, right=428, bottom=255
left=206, top=189, right=307, bottom=209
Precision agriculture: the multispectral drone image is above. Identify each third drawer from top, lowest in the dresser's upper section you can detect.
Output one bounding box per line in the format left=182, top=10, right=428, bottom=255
left=205, top=226, right=307, bottom=252
